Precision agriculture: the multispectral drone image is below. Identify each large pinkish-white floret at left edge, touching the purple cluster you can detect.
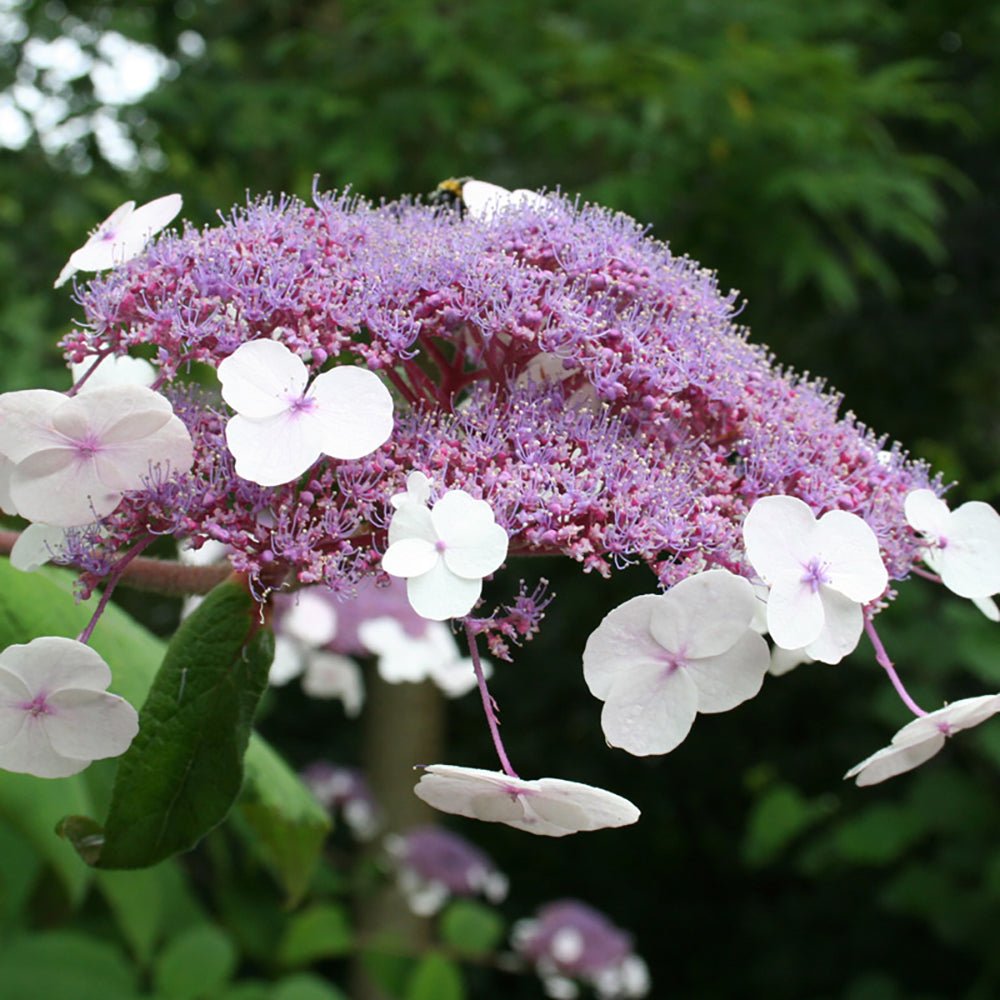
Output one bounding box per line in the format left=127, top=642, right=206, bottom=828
left=0, top=385, right=193, bottom=528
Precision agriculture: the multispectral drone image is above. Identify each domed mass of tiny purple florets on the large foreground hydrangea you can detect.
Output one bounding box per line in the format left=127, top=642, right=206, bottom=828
left=63, top=188, right=940, bottom=640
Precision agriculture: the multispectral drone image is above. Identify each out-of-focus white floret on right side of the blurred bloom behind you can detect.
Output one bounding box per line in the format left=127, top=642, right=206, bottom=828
left=358, top=615, right=492, bottom=698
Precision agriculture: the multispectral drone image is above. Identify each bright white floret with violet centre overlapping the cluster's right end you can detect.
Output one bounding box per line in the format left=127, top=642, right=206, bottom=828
left=743, top=496, right=889, bottom=663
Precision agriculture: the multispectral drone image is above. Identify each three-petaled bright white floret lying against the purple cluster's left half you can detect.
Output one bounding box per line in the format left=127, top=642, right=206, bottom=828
left=218, top=340, right=392, bottom=486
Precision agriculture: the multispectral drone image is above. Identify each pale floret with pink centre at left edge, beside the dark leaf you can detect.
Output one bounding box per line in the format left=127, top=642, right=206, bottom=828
left=0, top=636, right=139, bottom=778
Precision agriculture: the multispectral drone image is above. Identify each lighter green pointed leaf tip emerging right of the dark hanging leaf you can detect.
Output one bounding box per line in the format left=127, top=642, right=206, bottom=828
left=239, top=734, right=330, bottom=907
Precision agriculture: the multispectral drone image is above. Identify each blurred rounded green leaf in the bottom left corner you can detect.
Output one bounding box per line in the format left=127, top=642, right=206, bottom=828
left=0, top=931, right=139, bottom=1000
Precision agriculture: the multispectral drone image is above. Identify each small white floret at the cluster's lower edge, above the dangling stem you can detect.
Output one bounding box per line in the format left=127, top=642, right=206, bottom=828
left=382, top=472, right=508, bottom=621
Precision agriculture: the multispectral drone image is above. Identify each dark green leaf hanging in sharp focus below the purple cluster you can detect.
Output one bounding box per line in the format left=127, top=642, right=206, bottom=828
left=66, top=581, right=274, bottom=868
